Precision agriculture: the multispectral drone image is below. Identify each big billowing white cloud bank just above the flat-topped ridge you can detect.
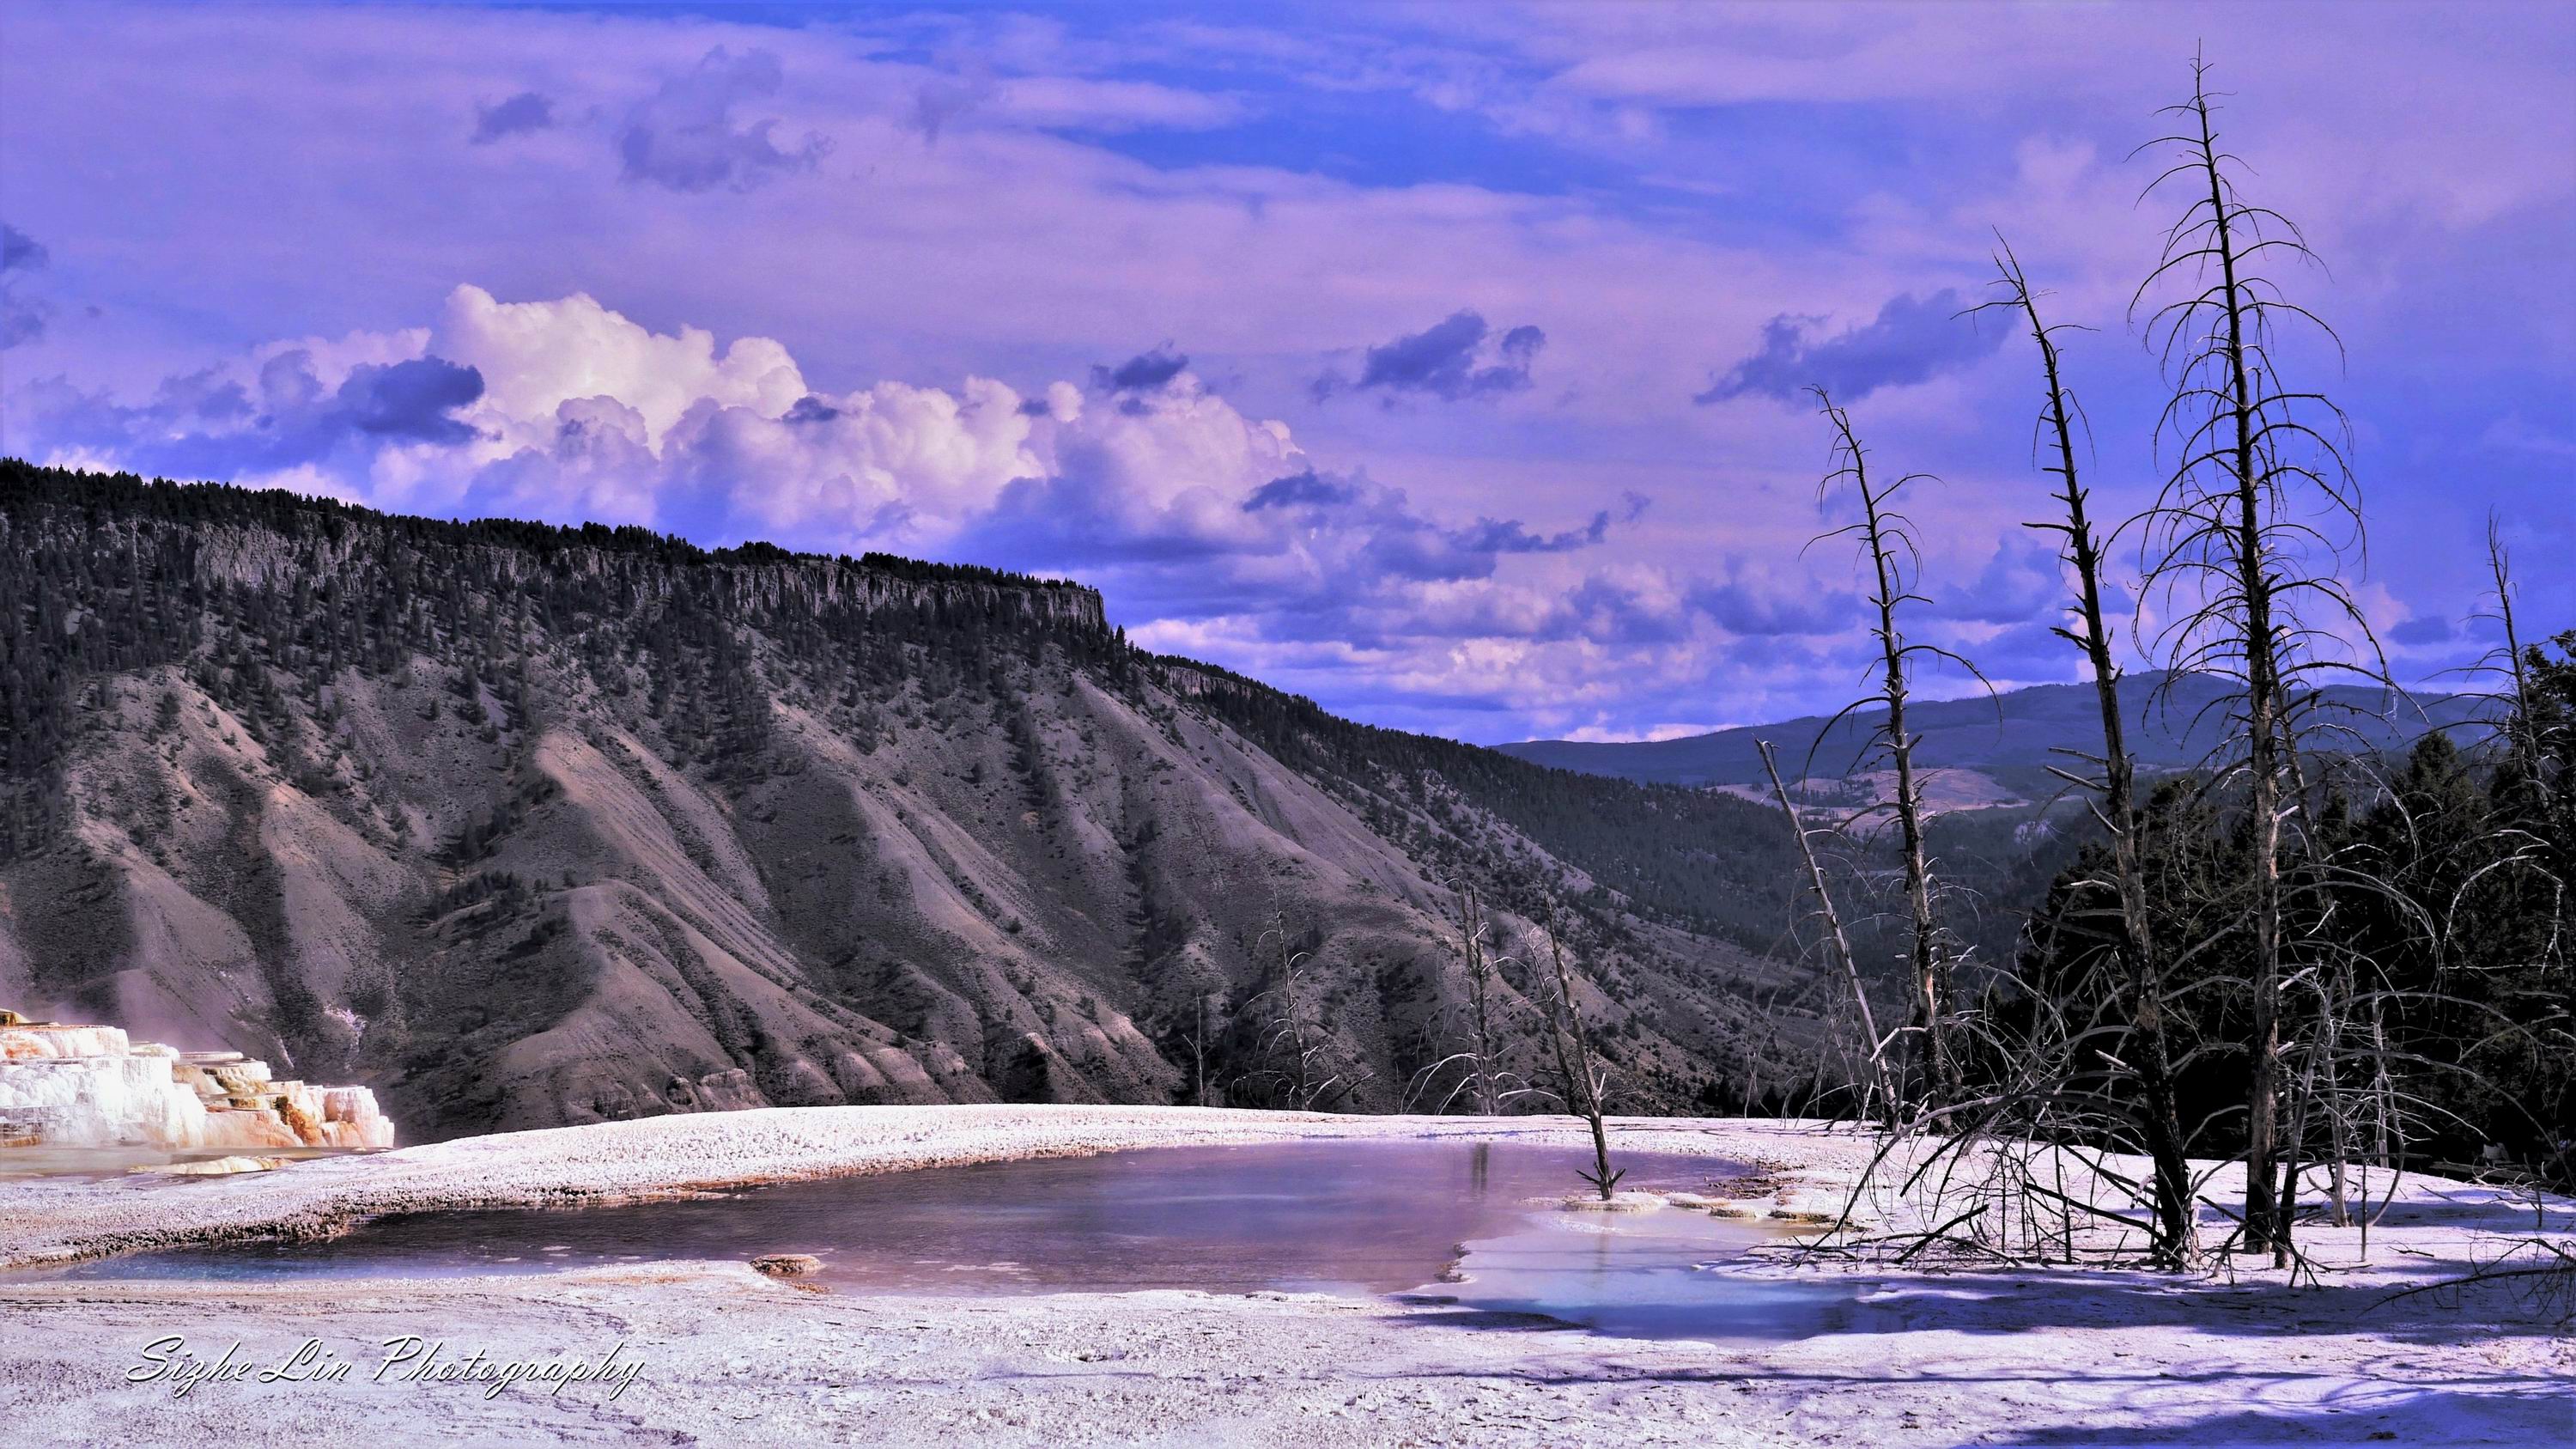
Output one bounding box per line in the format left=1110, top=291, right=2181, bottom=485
left=5, top=286, right=1066, bottom=549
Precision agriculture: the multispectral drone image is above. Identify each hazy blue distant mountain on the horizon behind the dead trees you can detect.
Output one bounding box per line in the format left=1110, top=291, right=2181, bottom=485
left=1499, top=673, right=2481, bottom=805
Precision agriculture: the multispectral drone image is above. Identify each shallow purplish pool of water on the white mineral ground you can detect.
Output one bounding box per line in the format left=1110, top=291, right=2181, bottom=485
left=50, top=1142, right=1847, bottom=1338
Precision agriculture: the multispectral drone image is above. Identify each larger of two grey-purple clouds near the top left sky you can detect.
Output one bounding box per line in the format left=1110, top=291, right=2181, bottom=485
left=618, top=46, right=829, bottom=191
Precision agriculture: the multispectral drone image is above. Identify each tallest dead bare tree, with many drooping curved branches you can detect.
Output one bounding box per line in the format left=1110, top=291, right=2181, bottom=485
left=2130, top=59, right=2385, bottom=1266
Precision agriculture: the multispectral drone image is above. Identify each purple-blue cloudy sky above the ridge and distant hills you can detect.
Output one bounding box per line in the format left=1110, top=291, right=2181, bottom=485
left=0, top=0, right=2576, bottom=743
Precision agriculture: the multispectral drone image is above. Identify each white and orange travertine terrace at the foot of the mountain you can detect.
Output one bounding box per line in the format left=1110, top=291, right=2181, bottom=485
left=0, top=1014, right=394, bottom=1153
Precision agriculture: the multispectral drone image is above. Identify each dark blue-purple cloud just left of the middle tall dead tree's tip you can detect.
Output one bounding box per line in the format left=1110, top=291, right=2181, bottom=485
left=1692, top=286, right=2004, bottom=405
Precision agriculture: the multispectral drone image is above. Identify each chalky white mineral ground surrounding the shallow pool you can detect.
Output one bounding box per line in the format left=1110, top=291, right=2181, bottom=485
left=0, top=1106, right=2576, bottom=1446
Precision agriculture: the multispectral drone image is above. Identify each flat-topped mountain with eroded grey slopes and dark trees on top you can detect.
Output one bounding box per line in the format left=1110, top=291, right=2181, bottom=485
left=0, top=464, right=1788, bottom=1137
